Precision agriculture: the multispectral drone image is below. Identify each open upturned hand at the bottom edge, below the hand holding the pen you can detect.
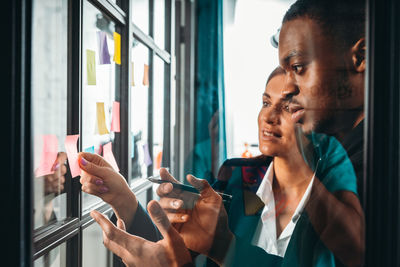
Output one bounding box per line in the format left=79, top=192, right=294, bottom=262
left=90, top=200, right=193, bottom=266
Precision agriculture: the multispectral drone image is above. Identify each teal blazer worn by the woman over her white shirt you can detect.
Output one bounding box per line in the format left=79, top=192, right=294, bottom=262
left=213, top=133, right=357, bottom=267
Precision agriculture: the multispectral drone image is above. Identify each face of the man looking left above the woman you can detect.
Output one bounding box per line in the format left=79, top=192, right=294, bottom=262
left=279, top=17, right=351, bottom=134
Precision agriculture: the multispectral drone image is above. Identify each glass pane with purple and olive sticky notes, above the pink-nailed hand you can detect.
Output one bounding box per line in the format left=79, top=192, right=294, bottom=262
left=81, top=2, right=119, bottom=209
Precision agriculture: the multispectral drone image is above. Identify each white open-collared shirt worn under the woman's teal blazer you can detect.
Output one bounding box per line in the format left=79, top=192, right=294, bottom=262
left=252, top=162, right=315, bottom=257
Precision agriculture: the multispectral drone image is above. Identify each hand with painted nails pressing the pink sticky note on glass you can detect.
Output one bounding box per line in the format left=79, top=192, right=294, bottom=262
left=79, top=152, right=138, bottom=227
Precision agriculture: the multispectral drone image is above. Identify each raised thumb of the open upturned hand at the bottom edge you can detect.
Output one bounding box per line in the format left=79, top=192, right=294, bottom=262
left=147, top=200, right=180, bottom=243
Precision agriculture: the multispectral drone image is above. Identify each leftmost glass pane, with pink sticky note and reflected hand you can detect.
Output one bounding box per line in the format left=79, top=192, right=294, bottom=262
left=32, top=0, right=68, bottom=229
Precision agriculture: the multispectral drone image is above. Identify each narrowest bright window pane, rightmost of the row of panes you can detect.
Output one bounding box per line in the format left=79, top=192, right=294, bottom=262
left=153, top=56, right=165, bottom=173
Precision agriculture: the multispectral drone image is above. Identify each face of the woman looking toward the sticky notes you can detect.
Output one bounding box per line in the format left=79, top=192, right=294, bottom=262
left=258, top=74, right=296, bottom=157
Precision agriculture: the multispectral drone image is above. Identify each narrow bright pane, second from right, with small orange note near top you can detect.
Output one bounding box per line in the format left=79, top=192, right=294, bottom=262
left=130, top=40, right=150, bottom=179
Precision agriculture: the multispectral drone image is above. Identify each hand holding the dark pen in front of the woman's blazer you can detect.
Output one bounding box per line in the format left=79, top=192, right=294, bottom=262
left=157, top=169, right=233, bottom=263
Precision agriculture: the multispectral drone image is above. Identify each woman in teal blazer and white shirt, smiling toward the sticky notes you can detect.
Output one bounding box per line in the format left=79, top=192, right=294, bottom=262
left=81, top=68, right=363, bottom=266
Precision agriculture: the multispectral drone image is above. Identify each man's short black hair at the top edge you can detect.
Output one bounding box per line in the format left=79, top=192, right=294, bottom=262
left=282, top=0, right=366, bottom=51
